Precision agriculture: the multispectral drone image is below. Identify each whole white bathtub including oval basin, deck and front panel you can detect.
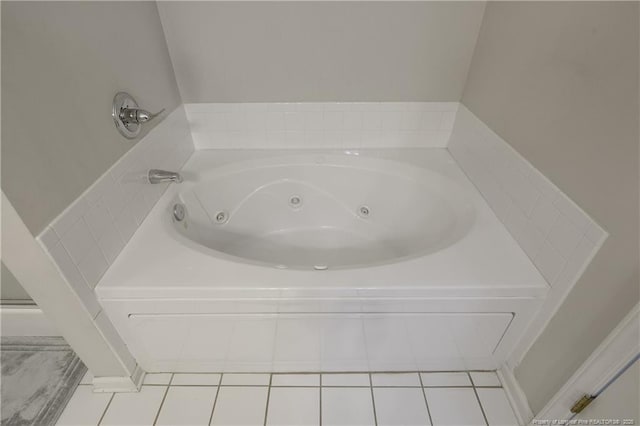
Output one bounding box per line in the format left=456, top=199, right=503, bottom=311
left=96, top=149, right=548, bottom=371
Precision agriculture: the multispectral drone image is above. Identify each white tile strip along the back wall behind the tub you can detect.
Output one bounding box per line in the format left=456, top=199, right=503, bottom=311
left=185, top=102, right=458, bottom=149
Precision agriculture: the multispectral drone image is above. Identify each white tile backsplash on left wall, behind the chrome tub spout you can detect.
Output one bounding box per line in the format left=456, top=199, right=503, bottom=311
left=37, top=106, right=194, bottom=317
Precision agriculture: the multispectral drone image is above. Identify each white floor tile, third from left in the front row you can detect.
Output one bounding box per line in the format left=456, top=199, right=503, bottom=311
left=156, top=386, right=218, bottom=426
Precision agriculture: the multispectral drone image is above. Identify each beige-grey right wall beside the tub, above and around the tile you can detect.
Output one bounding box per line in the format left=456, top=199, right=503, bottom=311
left=462, top=2, right=640, bottom=412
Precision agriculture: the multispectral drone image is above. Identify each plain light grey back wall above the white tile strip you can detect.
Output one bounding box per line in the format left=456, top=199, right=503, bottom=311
left=158, top=2, right=484, bottom=103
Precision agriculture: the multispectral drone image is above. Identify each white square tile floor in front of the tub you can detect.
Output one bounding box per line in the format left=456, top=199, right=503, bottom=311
left=57, top=372, right=518, bottom=426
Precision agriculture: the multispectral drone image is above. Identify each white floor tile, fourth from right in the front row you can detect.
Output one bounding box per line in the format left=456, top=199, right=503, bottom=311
left=322, top=388, right=375, bottom=426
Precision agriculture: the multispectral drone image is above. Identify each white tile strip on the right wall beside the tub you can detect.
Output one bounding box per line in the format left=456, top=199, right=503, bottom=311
left=448, top=104, right=608, bottom=362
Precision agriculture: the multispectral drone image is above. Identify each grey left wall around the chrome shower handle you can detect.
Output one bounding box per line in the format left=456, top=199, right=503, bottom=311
left=2, top=1, right=181, bottom=235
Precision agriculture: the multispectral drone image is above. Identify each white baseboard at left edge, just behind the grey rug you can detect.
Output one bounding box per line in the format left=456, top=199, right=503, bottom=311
left=0, top=305, right=60, bottom=337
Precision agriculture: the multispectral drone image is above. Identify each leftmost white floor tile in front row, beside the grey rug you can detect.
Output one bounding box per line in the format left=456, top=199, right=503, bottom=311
left=56, top=386, right=113, bottom=426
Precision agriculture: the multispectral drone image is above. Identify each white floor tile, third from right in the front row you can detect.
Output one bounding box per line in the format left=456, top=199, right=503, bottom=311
left=373, top=388, right=431, bottom=426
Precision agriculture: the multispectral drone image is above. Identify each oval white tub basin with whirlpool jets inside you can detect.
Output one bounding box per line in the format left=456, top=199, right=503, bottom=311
left=174, top=155, right=475, bottom=270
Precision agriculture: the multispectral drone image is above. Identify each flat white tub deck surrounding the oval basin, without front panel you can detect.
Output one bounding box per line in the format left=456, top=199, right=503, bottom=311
left=96, top=148, right=548, bottom=300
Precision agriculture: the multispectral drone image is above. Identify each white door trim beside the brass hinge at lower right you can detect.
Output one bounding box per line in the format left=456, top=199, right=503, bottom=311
left=536, top=303, right=640, bottom=420
